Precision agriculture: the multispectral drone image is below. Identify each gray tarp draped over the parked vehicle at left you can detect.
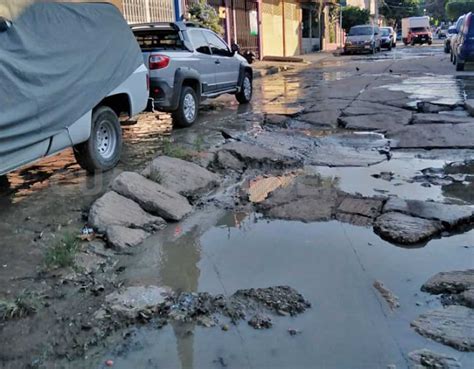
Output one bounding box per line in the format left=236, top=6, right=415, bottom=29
left=0, top=3, right=143, bottom=156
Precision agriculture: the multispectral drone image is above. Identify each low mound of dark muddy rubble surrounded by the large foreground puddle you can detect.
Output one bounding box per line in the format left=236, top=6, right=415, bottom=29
left=101, top=286, right=311, bottom=329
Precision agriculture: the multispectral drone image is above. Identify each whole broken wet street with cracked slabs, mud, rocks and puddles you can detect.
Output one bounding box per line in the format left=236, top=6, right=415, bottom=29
left=0, top=43, right=474, bottom=369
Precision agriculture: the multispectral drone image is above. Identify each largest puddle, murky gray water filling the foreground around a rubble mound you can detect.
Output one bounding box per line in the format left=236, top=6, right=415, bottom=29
left=93, top=211, right=474, bottom=369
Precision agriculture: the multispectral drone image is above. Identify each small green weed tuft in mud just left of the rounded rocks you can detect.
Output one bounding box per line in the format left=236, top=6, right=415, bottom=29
left=44, top=233, right=79, bottom=269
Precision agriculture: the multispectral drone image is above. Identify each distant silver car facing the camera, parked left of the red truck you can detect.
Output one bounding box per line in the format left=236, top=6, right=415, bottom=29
left=344, top=25, right=381, bottom=54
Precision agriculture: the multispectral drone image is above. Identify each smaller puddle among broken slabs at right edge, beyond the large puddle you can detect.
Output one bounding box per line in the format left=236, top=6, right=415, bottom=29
left=308, top=150, right=474, bottom=204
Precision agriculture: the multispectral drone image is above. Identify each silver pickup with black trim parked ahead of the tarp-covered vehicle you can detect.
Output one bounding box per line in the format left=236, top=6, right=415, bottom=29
left=131, top=22, right=253, bottom=127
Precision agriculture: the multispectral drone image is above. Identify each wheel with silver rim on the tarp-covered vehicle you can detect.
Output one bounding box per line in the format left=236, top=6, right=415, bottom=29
left=73, top=106, right=122, bottom=173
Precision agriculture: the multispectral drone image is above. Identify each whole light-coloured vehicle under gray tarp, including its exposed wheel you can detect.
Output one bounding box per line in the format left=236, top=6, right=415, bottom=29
left=0, top=3, right=148, bottom=175
